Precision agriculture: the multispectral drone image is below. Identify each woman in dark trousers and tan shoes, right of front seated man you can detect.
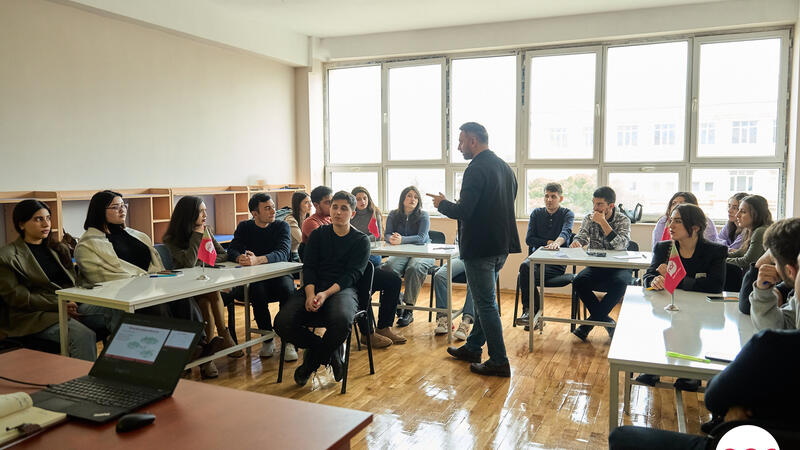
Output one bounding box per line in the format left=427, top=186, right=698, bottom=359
left=350, top=186, right=406, bottom=348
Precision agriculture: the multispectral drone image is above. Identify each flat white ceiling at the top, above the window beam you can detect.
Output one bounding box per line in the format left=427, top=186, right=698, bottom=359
left=203, top=0, right=721, bottom=38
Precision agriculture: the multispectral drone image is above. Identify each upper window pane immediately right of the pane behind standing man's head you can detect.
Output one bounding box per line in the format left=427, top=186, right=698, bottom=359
left=528, top=53, right=597, bottom=159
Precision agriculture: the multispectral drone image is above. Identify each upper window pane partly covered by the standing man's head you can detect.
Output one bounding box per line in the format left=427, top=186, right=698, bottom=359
left=450, top=56, right=517, bottom=163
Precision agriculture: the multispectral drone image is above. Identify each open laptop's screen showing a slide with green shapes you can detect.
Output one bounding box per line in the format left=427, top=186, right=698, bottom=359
left=89, top=314, right=203, bottom=391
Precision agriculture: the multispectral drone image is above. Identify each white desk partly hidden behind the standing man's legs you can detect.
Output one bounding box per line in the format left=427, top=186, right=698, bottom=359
left=370, top=241, right=458, bottom=343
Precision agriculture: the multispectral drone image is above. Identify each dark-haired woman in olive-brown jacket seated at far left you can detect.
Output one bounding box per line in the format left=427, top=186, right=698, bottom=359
left=0, top=200, right=111, bottom=361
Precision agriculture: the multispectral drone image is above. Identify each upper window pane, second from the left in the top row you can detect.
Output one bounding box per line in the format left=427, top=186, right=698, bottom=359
left=328, top=66, right=381, bottom=164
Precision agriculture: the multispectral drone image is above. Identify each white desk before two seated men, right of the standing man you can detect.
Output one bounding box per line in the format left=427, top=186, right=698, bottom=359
left=528, top=247, right=653, bottom=352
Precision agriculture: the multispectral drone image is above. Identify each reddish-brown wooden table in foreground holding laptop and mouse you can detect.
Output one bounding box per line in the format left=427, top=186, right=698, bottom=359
left=0, top=349, right=372, bottom=450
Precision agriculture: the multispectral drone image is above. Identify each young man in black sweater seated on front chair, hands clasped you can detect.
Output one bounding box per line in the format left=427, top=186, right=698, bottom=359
left=275, top=191, right=369, bottom=386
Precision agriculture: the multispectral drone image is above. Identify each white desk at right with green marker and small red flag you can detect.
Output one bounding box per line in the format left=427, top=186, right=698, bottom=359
left=608, top=286, right=755, bottom=430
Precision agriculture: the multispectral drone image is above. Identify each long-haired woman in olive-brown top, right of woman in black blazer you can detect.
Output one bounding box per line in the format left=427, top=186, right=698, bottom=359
left=725, top=195, right=772, bottom=292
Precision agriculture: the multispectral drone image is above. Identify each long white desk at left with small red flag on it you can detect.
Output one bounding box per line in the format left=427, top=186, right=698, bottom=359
left=56, top=262, right=303, bottom=367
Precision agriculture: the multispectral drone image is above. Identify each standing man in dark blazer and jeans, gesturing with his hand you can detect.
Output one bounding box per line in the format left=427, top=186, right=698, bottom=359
left=428, top=122, right=520, bottom=377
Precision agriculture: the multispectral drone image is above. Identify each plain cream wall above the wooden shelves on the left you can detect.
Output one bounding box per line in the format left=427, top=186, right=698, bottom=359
left=0, top=0, right=295, bottom=191
